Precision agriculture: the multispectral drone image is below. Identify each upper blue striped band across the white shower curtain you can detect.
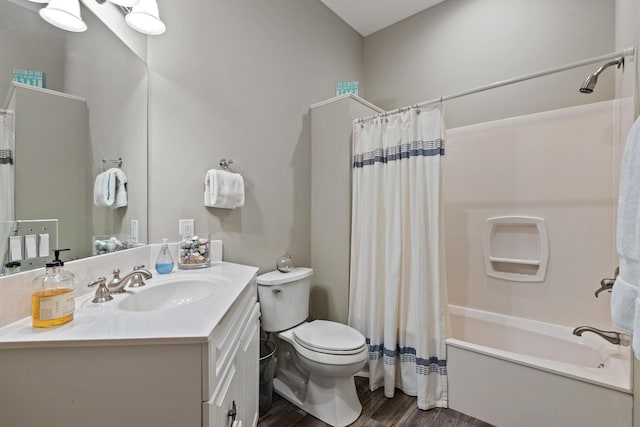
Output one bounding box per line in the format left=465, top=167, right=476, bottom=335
left=353, top=138, right=444, bottom=168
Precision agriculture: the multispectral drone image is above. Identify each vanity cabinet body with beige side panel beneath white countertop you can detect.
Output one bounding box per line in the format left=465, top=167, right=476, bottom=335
left=0, top=267, right=260, bottom=427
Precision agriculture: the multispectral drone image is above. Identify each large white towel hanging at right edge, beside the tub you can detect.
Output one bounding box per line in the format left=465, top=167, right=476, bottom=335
left=611, top=119, right=640, bottom=348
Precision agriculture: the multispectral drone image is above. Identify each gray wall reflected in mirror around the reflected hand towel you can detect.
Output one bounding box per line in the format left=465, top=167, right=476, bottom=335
left=64, top=10, right=149, bottom=246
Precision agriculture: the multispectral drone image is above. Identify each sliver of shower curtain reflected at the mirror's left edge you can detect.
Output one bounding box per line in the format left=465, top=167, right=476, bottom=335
left=0, top=111, right=15, bottom=273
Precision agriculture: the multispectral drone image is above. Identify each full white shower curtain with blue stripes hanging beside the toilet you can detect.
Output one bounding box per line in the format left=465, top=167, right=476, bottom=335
left=349, top=104, right=447, bottom=409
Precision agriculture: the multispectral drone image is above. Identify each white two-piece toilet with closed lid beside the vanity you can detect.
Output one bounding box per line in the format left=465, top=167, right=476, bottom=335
left=257, top=267, right=368, bottom=426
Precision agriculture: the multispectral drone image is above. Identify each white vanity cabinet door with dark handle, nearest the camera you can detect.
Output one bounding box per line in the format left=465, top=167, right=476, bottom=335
left=202, top=360, right=244, bottom=427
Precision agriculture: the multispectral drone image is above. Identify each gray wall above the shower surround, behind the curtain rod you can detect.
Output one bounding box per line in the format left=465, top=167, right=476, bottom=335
left=364, top=0, right=614, bottom=128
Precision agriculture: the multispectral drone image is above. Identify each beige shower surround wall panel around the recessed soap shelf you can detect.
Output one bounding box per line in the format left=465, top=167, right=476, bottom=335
left=444, top=100, right=630, bottom=330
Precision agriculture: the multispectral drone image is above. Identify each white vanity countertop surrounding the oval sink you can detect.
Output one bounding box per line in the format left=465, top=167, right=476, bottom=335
left=0, top=262, right=258, bottom=350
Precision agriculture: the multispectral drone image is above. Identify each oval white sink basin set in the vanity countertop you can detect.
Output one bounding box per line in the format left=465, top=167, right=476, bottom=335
left=118, top=278, right=230, bottom=311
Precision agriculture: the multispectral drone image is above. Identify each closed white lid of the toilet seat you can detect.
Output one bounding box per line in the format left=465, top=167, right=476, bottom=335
left=293, top=320, right=366, bottom=354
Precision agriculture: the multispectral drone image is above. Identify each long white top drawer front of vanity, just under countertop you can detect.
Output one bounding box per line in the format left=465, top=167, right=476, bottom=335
left=202, top=278, right=257, bottom=401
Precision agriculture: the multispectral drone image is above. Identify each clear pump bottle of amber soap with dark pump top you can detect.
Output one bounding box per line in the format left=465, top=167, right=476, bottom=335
left=31, top=249, right=75, bottom=328
